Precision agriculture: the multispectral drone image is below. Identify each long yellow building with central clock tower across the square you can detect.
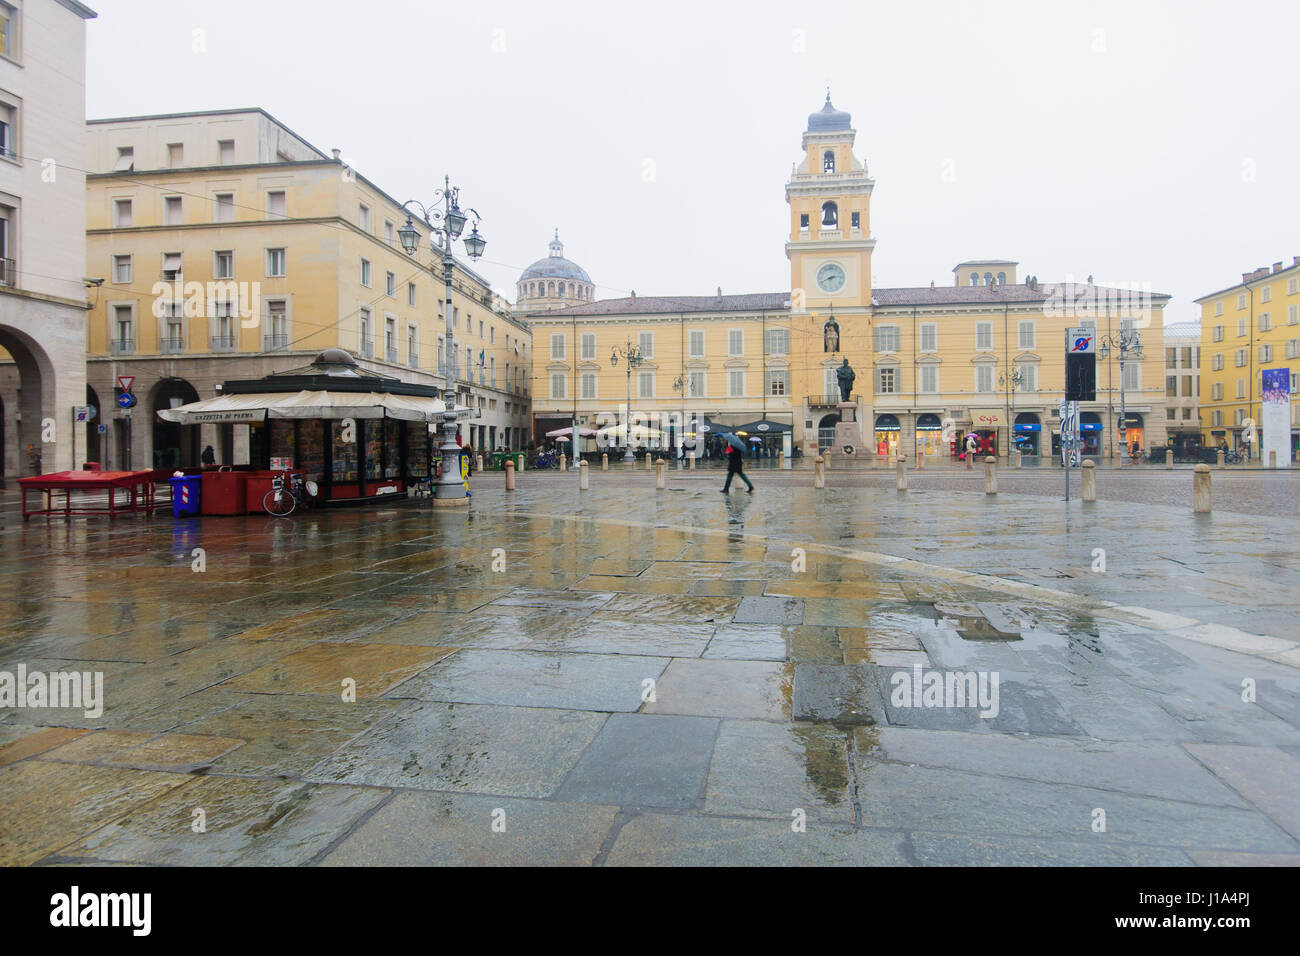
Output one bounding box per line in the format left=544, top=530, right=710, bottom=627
left=520, top=96, right=1169, bottom=460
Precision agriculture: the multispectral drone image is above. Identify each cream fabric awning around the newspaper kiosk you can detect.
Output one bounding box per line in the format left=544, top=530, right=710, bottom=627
left=159, top=390, right=457, bottom=425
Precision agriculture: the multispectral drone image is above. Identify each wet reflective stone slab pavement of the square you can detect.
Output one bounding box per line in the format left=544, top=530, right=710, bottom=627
left=0, top=472, right=1300, bottom=866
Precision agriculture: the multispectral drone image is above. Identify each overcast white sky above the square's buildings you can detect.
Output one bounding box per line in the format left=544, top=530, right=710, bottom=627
left=87, top=0, right=1300, bottom=321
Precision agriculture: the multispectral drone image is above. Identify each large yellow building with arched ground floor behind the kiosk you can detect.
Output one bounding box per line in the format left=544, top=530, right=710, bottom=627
left=86, top=109, right=532, bottom=468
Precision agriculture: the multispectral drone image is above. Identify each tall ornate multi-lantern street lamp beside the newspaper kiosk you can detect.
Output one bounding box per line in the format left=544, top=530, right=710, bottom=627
left=398, top=177, right=488, bottom=507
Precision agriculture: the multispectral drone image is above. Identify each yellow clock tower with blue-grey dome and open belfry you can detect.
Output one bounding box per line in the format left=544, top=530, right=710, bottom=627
left=785, top=91, right=876, bottom=453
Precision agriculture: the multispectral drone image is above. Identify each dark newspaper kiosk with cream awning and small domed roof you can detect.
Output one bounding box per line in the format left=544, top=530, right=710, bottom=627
left=159, top=349, right=462, bottom=502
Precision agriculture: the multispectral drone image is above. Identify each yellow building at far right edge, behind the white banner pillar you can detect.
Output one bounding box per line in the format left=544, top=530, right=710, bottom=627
left=1196, top=256, right=1300, bottom=460
